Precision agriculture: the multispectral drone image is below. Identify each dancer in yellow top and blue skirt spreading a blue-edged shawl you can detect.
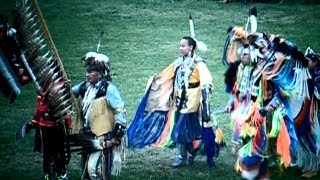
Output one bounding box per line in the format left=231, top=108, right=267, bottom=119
left=127, top=37, right=219, bottom=167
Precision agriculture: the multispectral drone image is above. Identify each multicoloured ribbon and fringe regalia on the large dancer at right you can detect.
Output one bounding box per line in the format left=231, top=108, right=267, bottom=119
left=224, top=23, right=319, bottom=179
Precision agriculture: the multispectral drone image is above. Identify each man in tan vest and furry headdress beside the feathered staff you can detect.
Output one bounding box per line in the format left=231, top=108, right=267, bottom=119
left=70, top=52, right=126, bottom=180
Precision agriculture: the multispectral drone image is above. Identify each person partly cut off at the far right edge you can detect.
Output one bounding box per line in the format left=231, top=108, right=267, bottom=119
left=293, top=47, right=320, bottom=178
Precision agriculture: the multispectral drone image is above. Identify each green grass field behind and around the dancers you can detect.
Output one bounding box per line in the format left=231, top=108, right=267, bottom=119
left=0, top=0, right=320, bottom=180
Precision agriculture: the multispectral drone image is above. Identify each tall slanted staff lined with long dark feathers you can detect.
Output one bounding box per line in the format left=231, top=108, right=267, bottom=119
left=8, top=0, right=72, bottom=121
